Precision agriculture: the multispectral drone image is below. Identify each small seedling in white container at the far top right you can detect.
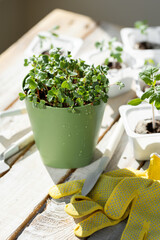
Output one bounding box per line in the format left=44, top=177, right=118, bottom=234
left=121, top=21, right=160, bottom=60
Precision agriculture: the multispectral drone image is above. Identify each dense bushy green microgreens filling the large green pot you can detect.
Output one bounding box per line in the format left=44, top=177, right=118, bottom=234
left=19, top=48, right=109, bottom=112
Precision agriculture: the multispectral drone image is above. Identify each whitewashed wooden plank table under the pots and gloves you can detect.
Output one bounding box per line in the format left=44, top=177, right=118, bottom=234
left=0, top=9, right=148, bottom=240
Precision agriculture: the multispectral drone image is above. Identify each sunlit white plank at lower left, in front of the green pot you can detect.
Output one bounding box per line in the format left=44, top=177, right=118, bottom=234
left=0, top=144, right=73, bottom=239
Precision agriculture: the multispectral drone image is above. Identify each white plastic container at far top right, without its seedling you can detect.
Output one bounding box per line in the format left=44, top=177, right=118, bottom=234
left=120, top=27, right=160, bottom=61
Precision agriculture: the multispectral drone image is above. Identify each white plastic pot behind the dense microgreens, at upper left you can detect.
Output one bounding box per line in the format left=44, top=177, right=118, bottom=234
left=25, top=31, right=83, bottom=57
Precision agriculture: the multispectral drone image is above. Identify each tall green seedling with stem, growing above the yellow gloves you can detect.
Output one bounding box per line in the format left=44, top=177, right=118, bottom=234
left=128, top=66, right=160, bottom=129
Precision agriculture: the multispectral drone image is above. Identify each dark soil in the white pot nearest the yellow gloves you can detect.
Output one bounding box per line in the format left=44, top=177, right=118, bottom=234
left=135, top=119, right=160, bottom=134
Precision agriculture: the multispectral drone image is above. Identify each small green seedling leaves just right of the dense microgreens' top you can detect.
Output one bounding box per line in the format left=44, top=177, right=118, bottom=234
left=95, top=38, right=123, bottom=65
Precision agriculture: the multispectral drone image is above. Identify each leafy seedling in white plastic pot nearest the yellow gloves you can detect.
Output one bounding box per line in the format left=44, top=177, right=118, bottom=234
left=120, top=66, right=160, bottom=160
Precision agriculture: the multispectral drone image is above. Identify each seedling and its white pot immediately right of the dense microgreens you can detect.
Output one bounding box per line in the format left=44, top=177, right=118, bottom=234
left=93, top=38, right=136, bottom=97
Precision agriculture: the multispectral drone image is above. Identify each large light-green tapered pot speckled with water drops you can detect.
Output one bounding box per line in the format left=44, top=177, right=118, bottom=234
left=26, top=99, right=105, bottom=168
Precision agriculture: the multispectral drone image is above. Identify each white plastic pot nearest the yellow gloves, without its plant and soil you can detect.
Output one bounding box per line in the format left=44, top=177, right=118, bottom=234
left=119, top=104, right=160, bottom=160
